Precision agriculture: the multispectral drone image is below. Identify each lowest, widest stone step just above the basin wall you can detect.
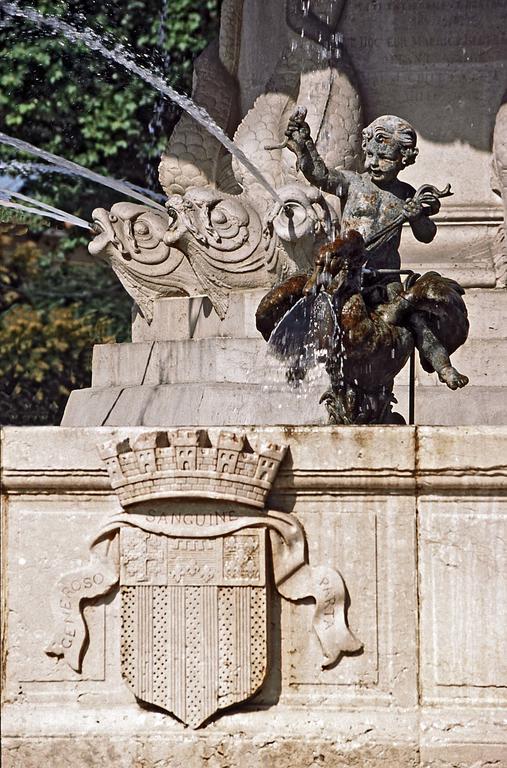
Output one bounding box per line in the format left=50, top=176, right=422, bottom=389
left=62, top=382, right=507, bottom=427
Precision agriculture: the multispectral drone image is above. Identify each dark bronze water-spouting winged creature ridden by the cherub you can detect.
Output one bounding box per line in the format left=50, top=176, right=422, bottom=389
left=256, top=230, right=469, bottom=424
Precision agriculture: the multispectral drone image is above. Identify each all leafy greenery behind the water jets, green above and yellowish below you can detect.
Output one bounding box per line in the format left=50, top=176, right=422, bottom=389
left=0, top=0, right=220, bottom=424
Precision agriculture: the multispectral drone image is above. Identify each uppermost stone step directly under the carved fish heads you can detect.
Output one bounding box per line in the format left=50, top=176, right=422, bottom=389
left=132, top=288, right=507, bottom=342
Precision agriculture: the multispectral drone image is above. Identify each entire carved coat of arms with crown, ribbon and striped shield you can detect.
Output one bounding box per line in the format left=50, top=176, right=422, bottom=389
left=46, top=430, right=361, bottom=728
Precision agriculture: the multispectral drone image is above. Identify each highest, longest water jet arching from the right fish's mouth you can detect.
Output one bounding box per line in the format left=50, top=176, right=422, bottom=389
left=0, top=1, right=282, bottom=205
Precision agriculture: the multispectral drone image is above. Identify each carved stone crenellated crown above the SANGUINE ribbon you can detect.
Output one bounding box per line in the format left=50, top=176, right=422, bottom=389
left=99, top=429, right=287, bottom=507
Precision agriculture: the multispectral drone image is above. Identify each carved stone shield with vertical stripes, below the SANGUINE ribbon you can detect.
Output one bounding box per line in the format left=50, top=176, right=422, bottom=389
left=120, top=515, right=267, bottom=728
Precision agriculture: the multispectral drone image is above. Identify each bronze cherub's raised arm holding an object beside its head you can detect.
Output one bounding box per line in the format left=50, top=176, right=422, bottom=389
left=285, top=108, right=348, bottom=197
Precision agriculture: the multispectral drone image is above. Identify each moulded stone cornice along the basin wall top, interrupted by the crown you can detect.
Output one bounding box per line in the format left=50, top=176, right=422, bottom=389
left=2, top=427, right=507, bottom=497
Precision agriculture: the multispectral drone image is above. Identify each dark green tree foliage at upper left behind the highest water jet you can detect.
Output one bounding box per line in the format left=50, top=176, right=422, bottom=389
left=0, top=0, right=218, bottom=202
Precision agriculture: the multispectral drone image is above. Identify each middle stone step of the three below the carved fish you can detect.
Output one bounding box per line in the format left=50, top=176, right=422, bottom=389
left=92, top=338, right=507, bottom=387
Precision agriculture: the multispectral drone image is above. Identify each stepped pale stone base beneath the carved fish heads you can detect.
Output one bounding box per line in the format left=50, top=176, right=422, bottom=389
left=62, top=288, right=507, bottom=427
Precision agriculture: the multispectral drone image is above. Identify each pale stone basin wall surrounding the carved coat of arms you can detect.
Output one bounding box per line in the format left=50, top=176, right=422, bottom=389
left=2, top=427, right=507, bottom=768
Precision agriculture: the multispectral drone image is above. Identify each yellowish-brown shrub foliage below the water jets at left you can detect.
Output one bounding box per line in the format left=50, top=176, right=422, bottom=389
left=0, top=235, right=117, bottom=424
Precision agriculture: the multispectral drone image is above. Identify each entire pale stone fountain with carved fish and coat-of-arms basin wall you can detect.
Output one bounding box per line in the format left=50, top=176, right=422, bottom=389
left=2, top=0, right=507, bottom=768
